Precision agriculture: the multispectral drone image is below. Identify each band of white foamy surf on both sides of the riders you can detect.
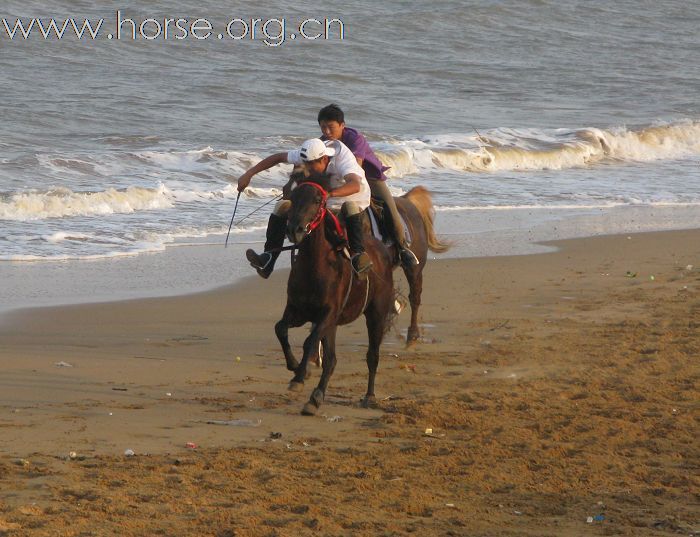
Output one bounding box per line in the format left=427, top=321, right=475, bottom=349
left=0, top=121, right=700, bottom=261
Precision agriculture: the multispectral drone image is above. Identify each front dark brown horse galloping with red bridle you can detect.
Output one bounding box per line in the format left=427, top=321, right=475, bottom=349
left=275, top=182, right=394, bottom=415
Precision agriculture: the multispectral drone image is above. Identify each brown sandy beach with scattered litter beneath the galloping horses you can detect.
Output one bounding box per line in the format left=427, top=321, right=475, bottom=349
left=0, top=231, right=700, bottom=537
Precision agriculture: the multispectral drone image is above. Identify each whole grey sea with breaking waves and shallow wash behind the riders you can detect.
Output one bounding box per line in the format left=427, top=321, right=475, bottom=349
left=0, top=0, right=700, bottom=305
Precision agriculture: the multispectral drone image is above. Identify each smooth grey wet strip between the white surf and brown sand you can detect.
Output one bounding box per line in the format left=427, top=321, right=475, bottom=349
left=0, top=203, right=700, bottom=316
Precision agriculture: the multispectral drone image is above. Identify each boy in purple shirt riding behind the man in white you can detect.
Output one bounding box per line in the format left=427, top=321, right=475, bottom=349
left=318, top=104, right=418, bottom=266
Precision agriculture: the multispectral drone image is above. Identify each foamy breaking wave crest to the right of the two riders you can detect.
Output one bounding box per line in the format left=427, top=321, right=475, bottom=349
left=377, top=121, right=700, bottom=177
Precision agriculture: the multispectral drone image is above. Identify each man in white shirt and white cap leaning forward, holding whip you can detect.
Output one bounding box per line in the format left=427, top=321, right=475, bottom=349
left=238, top=138, right=372, bottom=278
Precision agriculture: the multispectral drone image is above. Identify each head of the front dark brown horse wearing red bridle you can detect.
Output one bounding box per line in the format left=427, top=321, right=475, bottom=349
left=287, top=179, right=328, bottom=244
